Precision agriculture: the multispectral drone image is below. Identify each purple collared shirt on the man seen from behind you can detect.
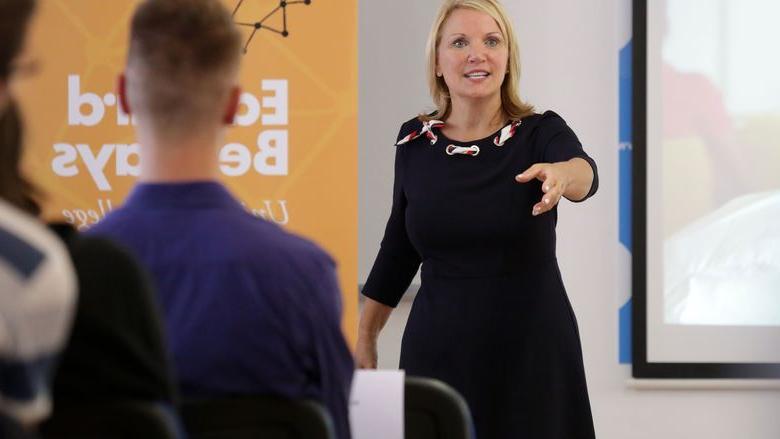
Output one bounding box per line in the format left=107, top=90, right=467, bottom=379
left=88, top=182, right=354, bottom=438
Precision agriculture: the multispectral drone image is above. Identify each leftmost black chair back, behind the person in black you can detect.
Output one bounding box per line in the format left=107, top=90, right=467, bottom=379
left=40, top=401, right=180, bottom=439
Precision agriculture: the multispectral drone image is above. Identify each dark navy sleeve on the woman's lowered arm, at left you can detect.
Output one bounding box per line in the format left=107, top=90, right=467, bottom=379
left=363, top=127, right=421, bottom=307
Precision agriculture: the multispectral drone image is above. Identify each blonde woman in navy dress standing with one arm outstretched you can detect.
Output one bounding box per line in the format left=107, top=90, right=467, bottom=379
left=356, top=0, right=598, bottom=439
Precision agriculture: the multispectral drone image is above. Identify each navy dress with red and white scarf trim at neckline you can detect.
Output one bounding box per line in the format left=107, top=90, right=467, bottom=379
left=363, top=111, right=598, bottom=439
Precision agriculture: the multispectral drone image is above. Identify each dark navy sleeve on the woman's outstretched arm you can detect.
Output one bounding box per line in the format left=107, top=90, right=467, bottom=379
left=540, top=111, right=599, bottom=203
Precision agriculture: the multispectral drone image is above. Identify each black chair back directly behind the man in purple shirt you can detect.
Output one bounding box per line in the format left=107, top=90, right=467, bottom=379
left=180, top=397, right=336, bottom=439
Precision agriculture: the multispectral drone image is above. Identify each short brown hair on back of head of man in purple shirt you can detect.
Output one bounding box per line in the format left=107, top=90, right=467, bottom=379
left=127, top=0, right=241, bottom=136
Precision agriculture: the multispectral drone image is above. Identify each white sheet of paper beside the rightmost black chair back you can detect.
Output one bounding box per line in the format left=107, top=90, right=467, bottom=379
left=349, top=369, right=405, bottom=439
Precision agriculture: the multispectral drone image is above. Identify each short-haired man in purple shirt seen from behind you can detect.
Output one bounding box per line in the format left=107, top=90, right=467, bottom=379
left=88, top=0, right=354, bottom=438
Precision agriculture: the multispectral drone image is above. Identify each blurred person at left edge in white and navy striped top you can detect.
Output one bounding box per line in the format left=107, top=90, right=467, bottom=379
left=0, top=0, right=76, bottom=438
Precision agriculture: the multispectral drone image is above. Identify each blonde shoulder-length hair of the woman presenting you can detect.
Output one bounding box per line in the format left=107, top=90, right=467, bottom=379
left=420, top=0, right=534, bottom=121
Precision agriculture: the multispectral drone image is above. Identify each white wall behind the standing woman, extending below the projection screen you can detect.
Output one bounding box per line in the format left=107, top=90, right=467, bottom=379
left=359, top=0, right=780, bottom=439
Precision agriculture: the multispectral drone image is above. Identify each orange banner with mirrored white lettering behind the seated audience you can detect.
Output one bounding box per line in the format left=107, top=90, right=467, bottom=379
left=19, top=0, right=358, bottom=342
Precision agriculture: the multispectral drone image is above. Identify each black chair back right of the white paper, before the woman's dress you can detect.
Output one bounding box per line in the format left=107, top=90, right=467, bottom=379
left=406, top=376, right=474, bottom=439
